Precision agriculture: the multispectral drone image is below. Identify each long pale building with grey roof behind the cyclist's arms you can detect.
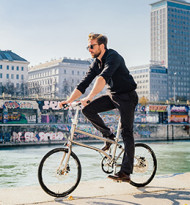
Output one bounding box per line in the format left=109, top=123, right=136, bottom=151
left=28, top=58, right=91, bottom=98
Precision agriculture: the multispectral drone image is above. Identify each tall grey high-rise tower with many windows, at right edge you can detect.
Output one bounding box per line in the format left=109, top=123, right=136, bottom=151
left=151, top=0, right=190, bottom=101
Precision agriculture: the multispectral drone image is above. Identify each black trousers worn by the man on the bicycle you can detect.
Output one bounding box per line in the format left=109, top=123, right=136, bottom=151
left=82, top=91, right=138, bottom=174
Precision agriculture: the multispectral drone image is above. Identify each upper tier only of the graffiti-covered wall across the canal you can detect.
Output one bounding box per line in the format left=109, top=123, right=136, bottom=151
left=0, top=100, right=190, bottom=124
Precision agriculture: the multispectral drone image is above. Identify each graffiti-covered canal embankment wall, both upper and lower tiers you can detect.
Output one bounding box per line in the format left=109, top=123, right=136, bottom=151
left=0, top=100, right=190, bottom=142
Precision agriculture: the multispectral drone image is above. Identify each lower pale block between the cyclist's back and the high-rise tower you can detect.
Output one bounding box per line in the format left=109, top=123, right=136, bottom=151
left=129, top=64, right=168, bottom=102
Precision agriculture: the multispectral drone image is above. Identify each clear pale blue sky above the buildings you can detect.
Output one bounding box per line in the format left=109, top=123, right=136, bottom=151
left=0, top=0, right=158, bottom=67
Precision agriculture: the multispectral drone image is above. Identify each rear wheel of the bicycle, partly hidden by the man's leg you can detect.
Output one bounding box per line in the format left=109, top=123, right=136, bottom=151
left=130, top=143, right=157, bottom=187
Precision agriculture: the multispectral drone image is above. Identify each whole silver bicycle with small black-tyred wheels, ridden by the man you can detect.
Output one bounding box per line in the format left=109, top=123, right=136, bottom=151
left=38, top=102, right=157, bottom=197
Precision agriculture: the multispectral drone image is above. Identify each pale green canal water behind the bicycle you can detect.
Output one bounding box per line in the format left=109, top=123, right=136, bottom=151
left=0, top=141, right=190, bottom=188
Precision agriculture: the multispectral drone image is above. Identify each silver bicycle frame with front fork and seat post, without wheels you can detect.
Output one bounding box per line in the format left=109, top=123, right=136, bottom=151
left=62, top=106, right=124, bottom=170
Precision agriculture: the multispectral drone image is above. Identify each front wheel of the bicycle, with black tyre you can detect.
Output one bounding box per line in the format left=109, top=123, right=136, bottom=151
left=38, top=148, right=82, bottom=197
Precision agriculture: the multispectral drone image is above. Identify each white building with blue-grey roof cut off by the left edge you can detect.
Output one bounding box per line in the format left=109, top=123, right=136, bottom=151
left=0, top=50, right=29, bottom=95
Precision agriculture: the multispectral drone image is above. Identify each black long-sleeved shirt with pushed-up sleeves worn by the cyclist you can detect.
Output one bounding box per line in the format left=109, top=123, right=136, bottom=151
left=77, top=49, right=137, bottom=94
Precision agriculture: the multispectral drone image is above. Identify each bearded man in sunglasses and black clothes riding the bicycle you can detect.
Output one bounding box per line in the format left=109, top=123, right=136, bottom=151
left=60, top=33, right=138, bottom=182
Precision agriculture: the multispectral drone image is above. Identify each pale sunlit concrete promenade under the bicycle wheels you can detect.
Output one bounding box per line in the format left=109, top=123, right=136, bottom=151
left=0, top=172, right=190, bottom=205
